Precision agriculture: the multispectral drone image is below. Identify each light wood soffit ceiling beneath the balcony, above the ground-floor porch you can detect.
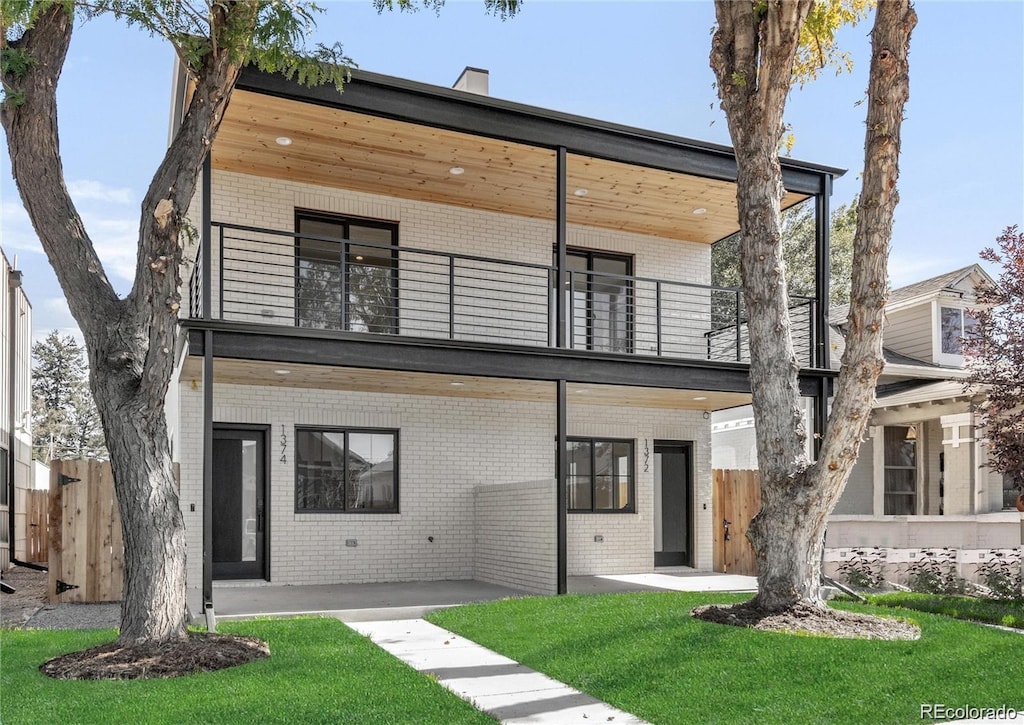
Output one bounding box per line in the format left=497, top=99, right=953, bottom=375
left=181, top=357, right=751, bottom=411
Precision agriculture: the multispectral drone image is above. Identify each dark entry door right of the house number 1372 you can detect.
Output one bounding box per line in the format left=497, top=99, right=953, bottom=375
left=654, top=440, right=693, bottom=566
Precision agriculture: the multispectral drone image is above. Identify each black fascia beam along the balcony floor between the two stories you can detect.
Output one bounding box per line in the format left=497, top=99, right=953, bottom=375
left=185, top=321, right=835, bottom=395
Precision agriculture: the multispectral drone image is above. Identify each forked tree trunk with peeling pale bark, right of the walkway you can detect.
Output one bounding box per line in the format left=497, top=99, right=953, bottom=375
left=711, top=0, right=916, bottom=610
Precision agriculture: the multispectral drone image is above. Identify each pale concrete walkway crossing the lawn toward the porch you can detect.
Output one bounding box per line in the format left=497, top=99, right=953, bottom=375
left=348, top=620, right=644, bottom=725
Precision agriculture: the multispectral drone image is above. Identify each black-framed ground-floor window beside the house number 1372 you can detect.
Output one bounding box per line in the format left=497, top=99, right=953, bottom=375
left=565, top=438, right=636, bottom=513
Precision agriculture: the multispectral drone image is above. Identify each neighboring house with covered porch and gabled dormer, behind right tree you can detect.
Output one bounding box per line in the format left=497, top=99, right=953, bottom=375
left=713, top=264, right=1024, bottom=572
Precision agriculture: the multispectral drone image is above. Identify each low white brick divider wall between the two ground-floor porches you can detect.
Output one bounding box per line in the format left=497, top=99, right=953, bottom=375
left=473, top=478, right=558, bottom=594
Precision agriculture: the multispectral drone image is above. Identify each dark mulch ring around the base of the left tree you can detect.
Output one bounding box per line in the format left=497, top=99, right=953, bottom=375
left=39, top=632, right=270, bottom=680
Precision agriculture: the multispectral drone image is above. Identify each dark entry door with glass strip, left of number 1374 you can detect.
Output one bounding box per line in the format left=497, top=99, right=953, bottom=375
left=212, top=428, right=266, bottom=579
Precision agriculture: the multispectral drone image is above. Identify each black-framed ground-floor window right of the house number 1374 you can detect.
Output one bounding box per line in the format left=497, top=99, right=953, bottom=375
left=295, top=428, right=398, bottom=513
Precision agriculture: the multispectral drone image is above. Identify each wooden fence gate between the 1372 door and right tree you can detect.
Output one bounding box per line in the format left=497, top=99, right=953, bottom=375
left=712, top=469, right=761, bottom=577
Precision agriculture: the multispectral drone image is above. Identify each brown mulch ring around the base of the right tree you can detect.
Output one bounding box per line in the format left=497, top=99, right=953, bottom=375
left=690, top=600, right=921, bottom=640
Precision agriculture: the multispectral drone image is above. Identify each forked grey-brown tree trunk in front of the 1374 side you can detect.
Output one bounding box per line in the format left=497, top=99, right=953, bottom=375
left=0, top=3, right=243, bottom=644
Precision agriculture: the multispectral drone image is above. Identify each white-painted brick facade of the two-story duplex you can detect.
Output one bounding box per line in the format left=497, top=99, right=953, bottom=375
left=176, top=166, right=712, bottom=611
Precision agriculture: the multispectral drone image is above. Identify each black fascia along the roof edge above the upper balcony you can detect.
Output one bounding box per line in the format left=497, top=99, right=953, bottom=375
left=237, top=68, right=846, bottom=195
